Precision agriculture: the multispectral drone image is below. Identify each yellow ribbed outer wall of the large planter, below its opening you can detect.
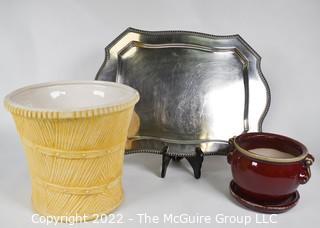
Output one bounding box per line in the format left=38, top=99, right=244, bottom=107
left=6, top=105, right=136, bottom=221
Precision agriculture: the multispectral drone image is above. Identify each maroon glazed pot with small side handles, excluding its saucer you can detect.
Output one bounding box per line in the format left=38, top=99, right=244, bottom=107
left=227, top=132, right=314, bottom=203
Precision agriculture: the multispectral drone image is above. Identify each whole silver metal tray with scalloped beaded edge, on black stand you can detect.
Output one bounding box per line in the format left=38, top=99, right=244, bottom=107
left=96, top=28, right=270, bottom=156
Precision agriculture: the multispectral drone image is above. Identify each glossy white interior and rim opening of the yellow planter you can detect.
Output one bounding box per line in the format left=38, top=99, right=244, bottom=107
left=5, top=81, right=139, bottom=112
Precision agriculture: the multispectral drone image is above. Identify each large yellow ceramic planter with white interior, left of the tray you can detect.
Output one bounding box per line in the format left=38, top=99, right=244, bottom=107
left=5, top=81, right=139, bottom=221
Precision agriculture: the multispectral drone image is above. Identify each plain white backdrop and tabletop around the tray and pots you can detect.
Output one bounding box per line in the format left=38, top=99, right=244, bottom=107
left=0, top=0, right=320, bottom=227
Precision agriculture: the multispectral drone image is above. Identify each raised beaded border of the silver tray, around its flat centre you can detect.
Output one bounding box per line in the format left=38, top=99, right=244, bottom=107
left=95, top=28, right=271, bottom=157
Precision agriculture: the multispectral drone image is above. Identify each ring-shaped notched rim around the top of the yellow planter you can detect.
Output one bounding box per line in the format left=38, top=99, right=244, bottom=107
left=4, top=81, right=140, bottom=119
